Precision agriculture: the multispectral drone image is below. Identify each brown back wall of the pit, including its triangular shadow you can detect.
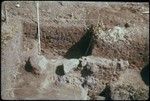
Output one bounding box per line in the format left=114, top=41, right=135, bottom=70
left=23, top=22, right=93, bottom=59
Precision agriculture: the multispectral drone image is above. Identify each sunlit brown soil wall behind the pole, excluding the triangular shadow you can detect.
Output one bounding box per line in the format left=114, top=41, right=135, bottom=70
left=23, top=22, right=86, bottom=57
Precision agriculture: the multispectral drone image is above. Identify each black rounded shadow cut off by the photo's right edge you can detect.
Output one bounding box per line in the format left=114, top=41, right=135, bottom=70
left=140, top=64, right=149, bottom=86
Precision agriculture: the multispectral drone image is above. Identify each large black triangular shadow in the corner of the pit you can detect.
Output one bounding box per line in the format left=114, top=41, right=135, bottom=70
left=64, top=26, right=93, bottom=59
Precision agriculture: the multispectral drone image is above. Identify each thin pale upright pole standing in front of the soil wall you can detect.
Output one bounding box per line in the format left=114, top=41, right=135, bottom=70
left=37, top=2, right=41, bottom=54
